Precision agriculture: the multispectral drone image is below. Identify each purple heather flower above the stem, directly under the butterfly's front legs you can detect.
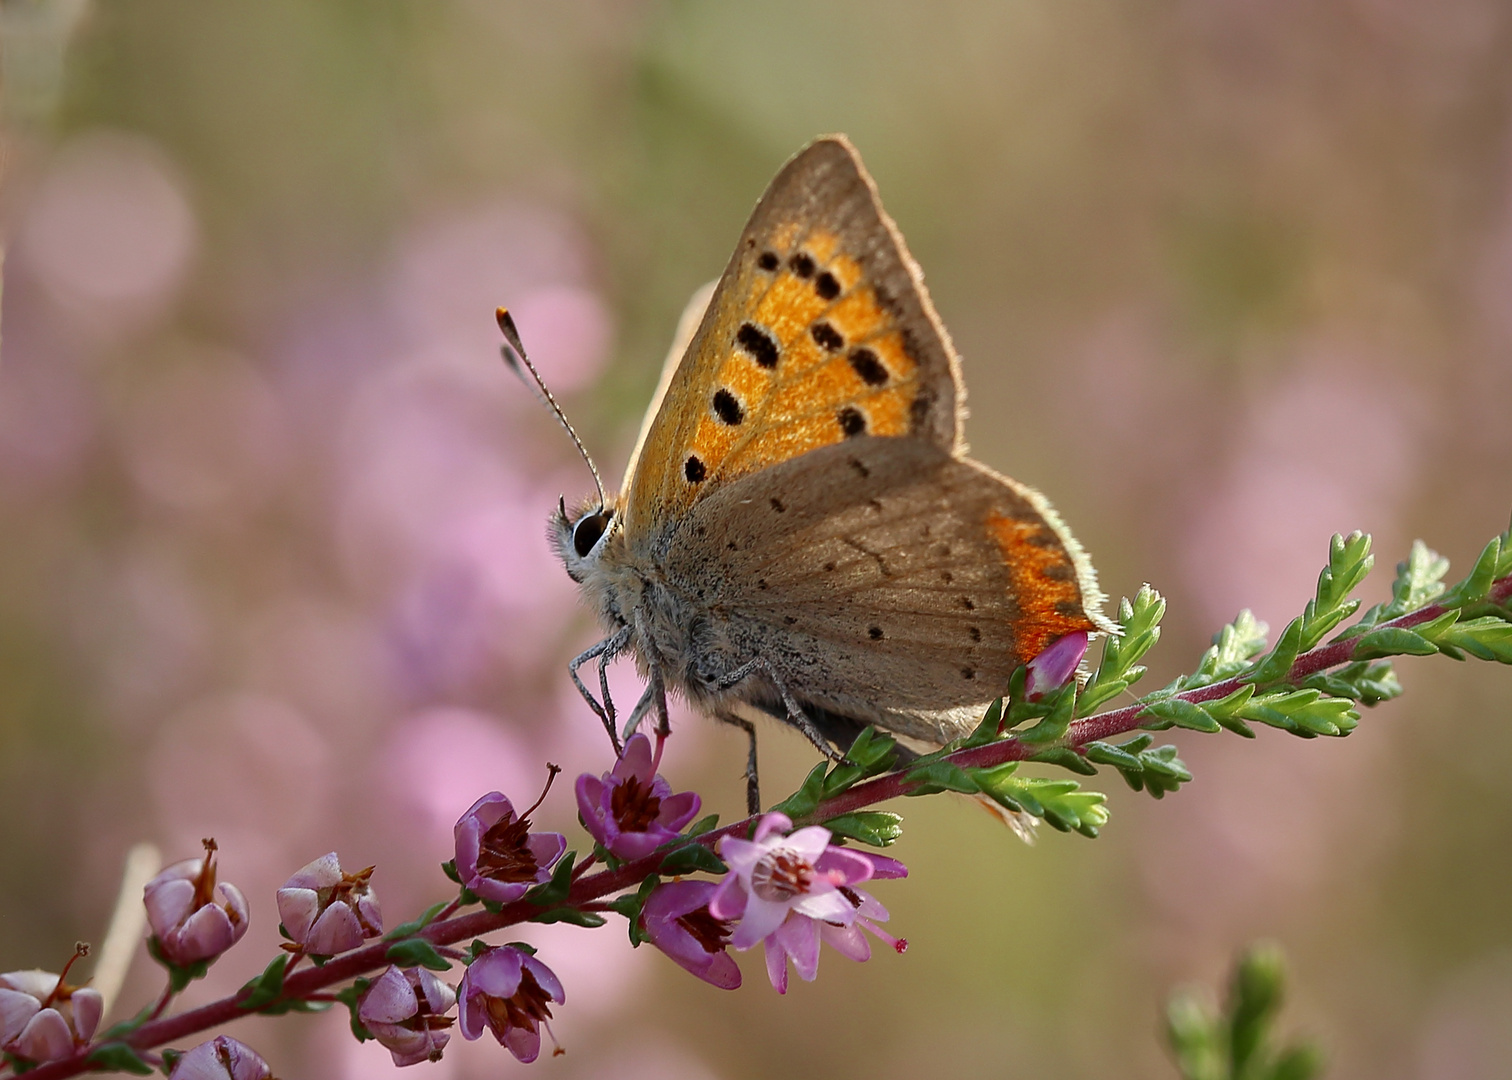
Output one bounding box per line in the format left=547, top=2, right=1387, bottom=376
left=578, top=734, right=702, bottom=859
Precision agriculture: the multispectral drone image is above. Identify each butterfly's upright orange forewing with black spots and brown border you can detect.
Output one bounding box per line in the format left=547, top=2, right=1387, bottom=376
left=626, top=138, right=962, bottom=535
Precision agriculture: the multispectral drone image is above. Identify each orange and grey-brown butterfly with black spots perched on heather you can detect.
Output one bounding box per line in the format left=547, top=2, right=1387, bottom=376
left=499, top=136, right=1111, bottom=814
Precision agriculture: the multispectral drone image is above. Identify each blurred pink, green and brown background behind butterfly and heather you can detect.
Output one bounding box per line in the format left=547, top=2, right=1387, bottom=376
left=0, top=0, right=1512, bottom=1080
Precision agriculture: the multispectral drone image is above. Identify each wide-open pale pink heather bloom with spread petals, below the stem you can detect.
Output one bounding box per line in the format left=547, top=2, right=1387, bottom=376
left=709, top=814, right=907, bottom=994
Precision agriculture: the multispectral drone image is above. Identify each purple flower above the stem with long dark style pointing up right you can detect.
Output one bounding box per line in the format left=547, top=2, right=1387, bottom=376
left=455, top=791, right=567, bottom=903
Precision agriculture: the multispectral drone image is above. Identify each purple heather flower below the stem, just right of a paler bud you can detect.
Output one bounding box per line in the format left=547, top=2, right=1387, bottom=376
left=457, top=945, right=567, bottom=1063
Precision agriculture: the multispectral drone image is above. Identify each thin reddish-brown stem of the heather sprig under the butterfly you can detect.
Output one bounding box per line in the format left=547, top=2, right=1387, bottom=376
left=17, top=575, right=1512, bottom=1080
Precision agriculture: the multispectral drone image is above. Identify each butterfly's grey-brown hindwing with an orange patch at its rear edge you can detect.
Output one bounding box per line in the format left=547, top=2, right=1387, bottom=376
left=665, top=439, right=1101, bottom=741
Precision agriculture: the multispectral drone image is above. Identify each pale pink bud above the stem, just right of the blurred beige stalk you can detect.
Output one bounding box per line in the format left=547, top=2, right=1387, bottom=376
left=142, top=839, right=248, bottom=967
